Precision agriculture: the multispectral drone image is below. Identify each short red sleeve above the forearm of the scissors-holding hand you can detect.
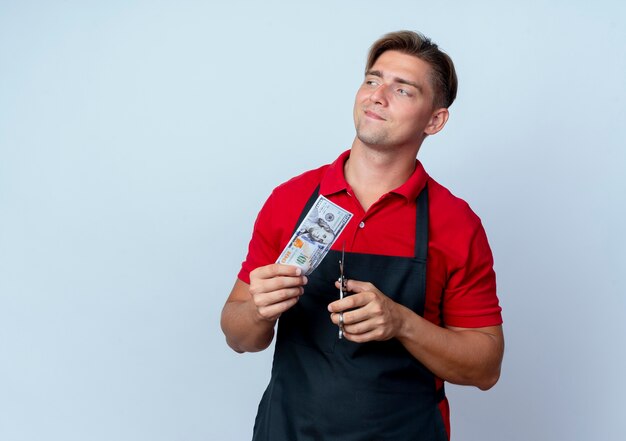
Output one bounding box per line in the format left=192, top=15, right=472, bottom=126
left=443, top=221, right=502, bottom=328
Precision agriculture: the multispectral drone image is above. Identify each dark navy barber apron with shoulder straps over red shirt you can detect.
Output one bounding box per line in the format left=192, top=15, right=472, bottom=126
left=253, top=187, right=448, bottom=441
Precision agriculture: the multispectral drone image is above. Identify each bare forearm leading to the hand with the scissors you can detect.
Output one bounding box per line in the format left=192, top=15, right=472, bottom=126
left=396, top=307, right=504, bottom=390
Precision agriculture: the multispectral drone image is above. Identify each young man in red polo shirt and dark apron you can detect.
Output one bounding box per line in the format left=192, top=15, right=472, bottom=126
left=222, top=31, right=504, bottom=441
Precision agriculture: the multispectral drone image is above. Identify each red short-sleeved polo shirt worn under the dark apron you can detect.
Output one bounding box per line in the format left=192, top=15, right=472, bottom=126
left=239, top=150, right=502, bottom=328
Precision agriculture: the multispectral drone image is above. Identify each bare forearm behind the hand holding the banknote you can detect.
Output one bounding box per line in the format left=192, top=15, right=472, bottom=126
left=221, top=300, right=276, bottom=353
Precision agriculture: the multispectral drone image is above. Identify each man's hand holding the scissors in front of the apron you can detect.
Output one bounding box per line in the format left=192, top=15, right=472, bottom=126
left=328, top=280, right=406, bottom=343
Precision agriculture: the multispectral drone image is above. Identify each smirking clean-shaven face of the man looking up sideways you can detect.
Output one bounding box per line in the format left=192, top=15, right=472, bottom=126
left=354, top=51, right=435, bottom=147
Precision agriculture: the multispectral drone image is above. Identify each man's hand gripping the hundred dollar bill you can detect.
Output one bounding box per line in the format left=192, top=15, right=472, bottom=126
left=249, top=263, right=308, bottom=322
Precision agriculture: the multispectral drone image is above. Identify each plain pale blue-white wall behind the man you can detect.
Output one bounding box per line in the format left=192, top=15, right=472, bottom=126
left=0, top=0, right=626, bottom=441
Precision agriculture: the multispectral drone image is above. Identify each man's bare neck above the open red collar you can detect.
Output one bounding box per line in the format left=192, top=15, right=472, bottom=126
left=344, top=138, right=419, bottom=211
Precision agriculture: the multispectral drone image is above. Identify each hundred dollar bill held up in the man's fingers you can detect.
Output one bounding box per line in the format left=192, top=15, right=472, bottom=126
left=276, top=195, right=352, bottom=275
